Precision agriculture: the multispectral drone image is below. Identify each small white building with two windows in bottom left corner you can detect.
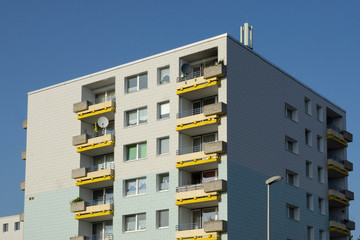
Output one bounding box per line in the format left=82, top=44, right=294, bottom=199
left=0, top=214, right=23, bottom=240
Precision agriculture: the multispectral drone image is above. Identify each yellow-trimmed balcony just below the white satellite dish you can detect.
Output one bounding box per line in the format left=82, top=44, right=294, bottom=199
left=73, top=130, right=115, bottom=156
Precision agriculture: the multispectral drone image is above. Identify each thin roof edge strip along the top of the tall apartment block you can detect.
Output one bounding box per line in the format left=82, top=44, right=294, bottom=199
left=28, top=33, right=346, bottom=113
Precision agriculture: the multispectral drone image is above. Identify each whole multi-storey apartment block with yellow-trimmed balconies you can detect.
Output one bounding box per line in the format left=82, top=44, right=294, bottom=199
left=23, top=34, right=355, bottom=240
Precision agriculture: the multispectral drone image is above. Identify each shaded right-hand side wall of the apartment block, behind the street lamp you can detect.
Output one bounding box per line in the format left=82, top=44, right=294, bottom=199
left=227, top=38, right=345, bottom=239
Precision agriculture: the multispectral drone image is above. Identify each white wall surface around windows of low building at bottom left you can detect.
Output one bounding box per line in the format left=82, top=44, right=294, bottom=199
left=0, top=215, right=24, bottom=240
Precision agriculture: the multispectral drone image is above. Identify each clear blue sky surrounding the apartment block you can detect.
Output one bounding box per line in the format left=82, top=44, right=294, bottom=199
left=0, top=0, right=360, bottom=236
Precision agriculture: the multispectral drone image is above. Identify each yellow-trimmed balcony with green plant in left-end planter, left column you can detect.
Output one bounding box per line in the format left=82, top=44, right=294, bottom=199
left=70, top=199, right=114, bottom=222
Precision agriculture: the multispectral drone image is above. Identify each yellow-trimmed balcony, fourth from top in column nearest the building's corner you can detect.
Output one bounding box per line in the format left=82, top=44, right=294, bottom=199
left=175, top=180, right=227, bottom=209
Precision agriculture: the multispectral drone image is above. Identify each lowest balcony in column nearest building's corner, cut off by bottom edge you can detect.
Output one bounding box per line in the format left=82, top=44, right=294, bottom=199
left=175, top=220, right=227, bottom=240
